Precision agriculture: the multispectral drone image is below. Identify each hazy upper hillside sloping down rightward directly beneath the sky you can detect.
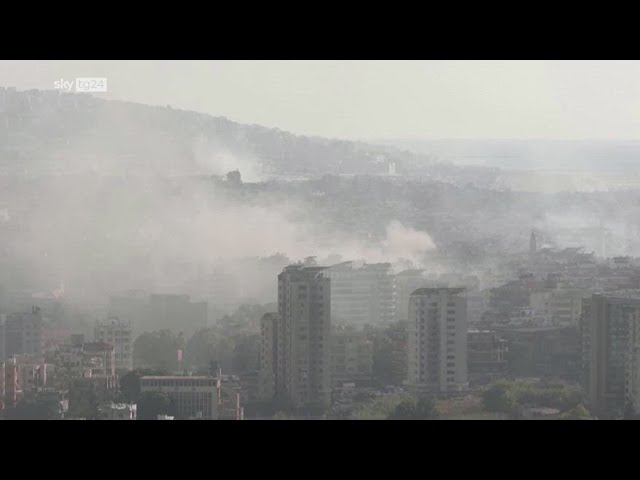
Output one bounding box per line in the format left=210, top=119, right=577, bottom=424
left=0, top=87, right=496, bottom=184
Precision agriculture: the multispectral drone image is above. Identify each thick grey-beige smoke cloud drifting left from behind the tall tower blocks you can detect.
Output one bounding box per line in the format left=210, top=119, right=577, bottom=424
left=2, top=125, right=434, bottom=310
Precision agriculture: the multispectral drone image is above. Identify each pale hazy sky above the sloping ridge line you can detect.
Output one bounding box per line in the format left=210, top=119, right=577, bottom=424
left=0, top=60, right=640, bottom=140
